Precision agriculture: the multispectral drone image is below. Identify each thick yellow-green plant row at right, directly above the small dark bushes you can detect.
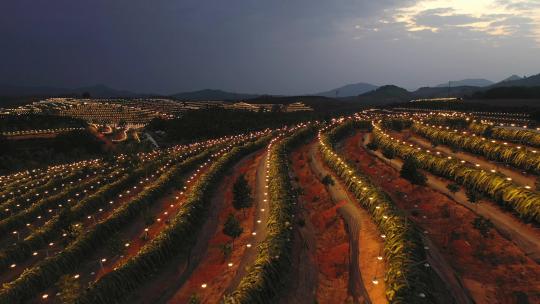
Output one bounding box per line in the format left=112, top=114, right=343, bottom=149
left=373, top=128, right=540, bottom=223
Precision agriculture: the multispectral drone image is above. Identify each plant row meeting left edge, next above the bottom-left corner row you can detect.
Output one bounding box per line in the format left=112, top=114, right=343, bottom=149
left=0, top=146, right=198, bottom=271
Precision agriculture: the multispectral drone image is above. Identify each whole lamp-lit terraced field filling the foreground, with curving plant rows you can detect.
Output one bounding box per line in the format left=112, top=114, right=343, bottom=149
left=0, top=111, right=540, bottom=304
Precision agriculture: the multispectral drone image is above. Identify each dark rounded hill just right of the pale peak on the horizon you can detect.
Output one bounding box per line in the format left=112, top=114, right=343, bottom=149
left=346, top=85, right=415, bottom=105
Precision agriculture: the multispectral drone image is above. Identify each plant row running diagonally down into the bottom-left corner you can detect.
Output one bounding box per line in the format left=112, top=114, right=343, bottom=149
left=0, top=147, right=217, bottom=303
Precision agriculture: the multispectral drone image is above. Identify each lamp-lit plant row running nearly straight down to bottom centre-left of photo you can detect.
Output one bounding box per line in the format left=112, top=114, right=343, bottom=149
left=225, top=127, right=316, bottom=304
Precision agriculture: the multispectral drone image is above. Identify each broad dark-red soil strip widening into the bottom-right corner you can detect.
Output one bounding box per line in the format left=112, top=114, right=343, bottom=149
left=343, top=134, right=540, bottom=303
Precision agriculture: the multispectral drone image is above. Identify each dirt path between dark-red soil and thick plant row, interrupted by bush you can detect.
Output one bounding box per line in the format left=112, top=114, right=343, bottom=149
left=359, top=134, right=540, bottom=263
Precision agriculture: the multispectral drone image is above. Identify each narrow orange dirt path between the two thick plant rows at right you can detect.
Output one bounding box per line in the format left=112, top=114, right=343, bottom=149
left=400, top=132, right=536, bottom=189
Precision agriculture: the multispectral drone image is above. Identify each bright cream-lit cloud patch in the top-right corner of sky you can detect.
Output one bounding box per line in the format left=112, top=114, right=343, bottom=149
left=352, top=0, right=540, bottom=45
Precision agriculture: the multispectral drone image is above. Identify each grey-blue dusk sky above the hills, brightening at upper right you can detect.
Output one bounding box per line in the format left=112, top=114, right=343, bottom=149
left=0, top=0, right=540, bottom=94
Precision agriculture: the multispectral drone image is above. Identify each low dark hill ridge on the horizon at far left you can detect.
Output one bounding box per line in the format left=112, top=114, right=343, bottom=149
left=0, top=84, right=141, bottom=98
